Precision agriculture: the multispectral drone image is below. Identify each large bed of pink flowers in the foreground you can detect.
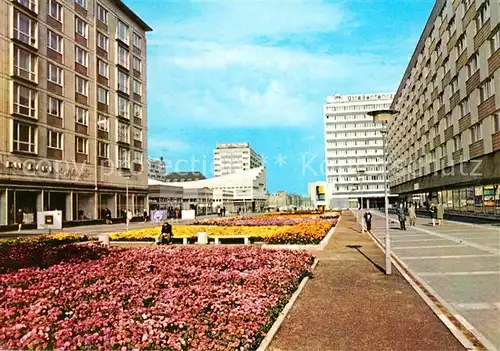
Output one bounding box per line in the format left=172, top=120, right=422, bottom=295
left=0, top=247, right=312, bottom=350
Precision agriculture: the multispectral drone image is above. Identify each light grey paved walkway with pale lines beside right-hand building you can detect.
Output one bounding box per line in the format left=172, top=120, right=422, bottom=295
left=366, top=212, right=500, bottom=350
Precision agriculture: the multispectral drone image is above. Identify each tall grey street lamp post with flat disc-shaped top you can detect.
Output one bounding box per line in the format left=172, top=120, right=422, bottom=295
left=368, top=110, right=398, bottom=274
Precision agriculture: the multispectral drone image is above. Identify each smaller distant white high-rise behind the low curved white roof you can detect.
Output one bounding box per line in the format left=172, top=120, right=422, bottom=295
left=214, top=143, right=263, bottom=177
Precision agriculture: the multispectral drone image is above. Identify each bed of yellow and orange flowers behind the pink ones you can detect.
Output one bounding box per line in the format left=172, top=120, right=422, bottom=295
left=110, top=219, right=336, bottom=244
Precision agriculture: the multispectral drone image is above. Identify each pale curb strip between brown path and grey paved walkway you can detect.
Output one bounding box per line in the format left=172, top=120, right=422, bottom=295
left=367, top=232, right=495, bottom=350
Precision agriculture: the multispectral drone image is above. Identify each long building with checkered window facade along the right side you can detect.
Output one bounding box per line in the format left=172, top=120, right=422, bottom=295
left=388, top=0, right=500, bottom=214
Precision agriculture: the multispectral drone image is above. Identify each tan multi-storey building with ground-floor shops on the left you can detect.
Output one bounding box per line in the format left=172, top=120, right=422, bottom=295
left=0, top=0, right=151, bottom=225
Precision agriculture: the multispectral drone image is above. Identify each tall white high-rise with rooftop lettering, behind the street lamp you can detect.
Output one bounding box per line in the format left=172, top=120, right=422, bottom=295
left=323, top=93, right=394, bottom=208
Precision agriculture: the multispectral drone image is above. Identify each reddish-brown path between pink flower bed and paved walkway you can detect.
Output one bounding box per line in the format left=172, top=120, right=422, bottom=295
left=269, top=213, right=464, bottom=351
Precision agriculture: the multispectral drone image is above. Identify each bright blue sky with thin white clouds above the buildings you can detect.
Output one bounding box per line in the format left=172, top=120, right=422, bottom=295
left=125, top=0, right=434, bottom=194
